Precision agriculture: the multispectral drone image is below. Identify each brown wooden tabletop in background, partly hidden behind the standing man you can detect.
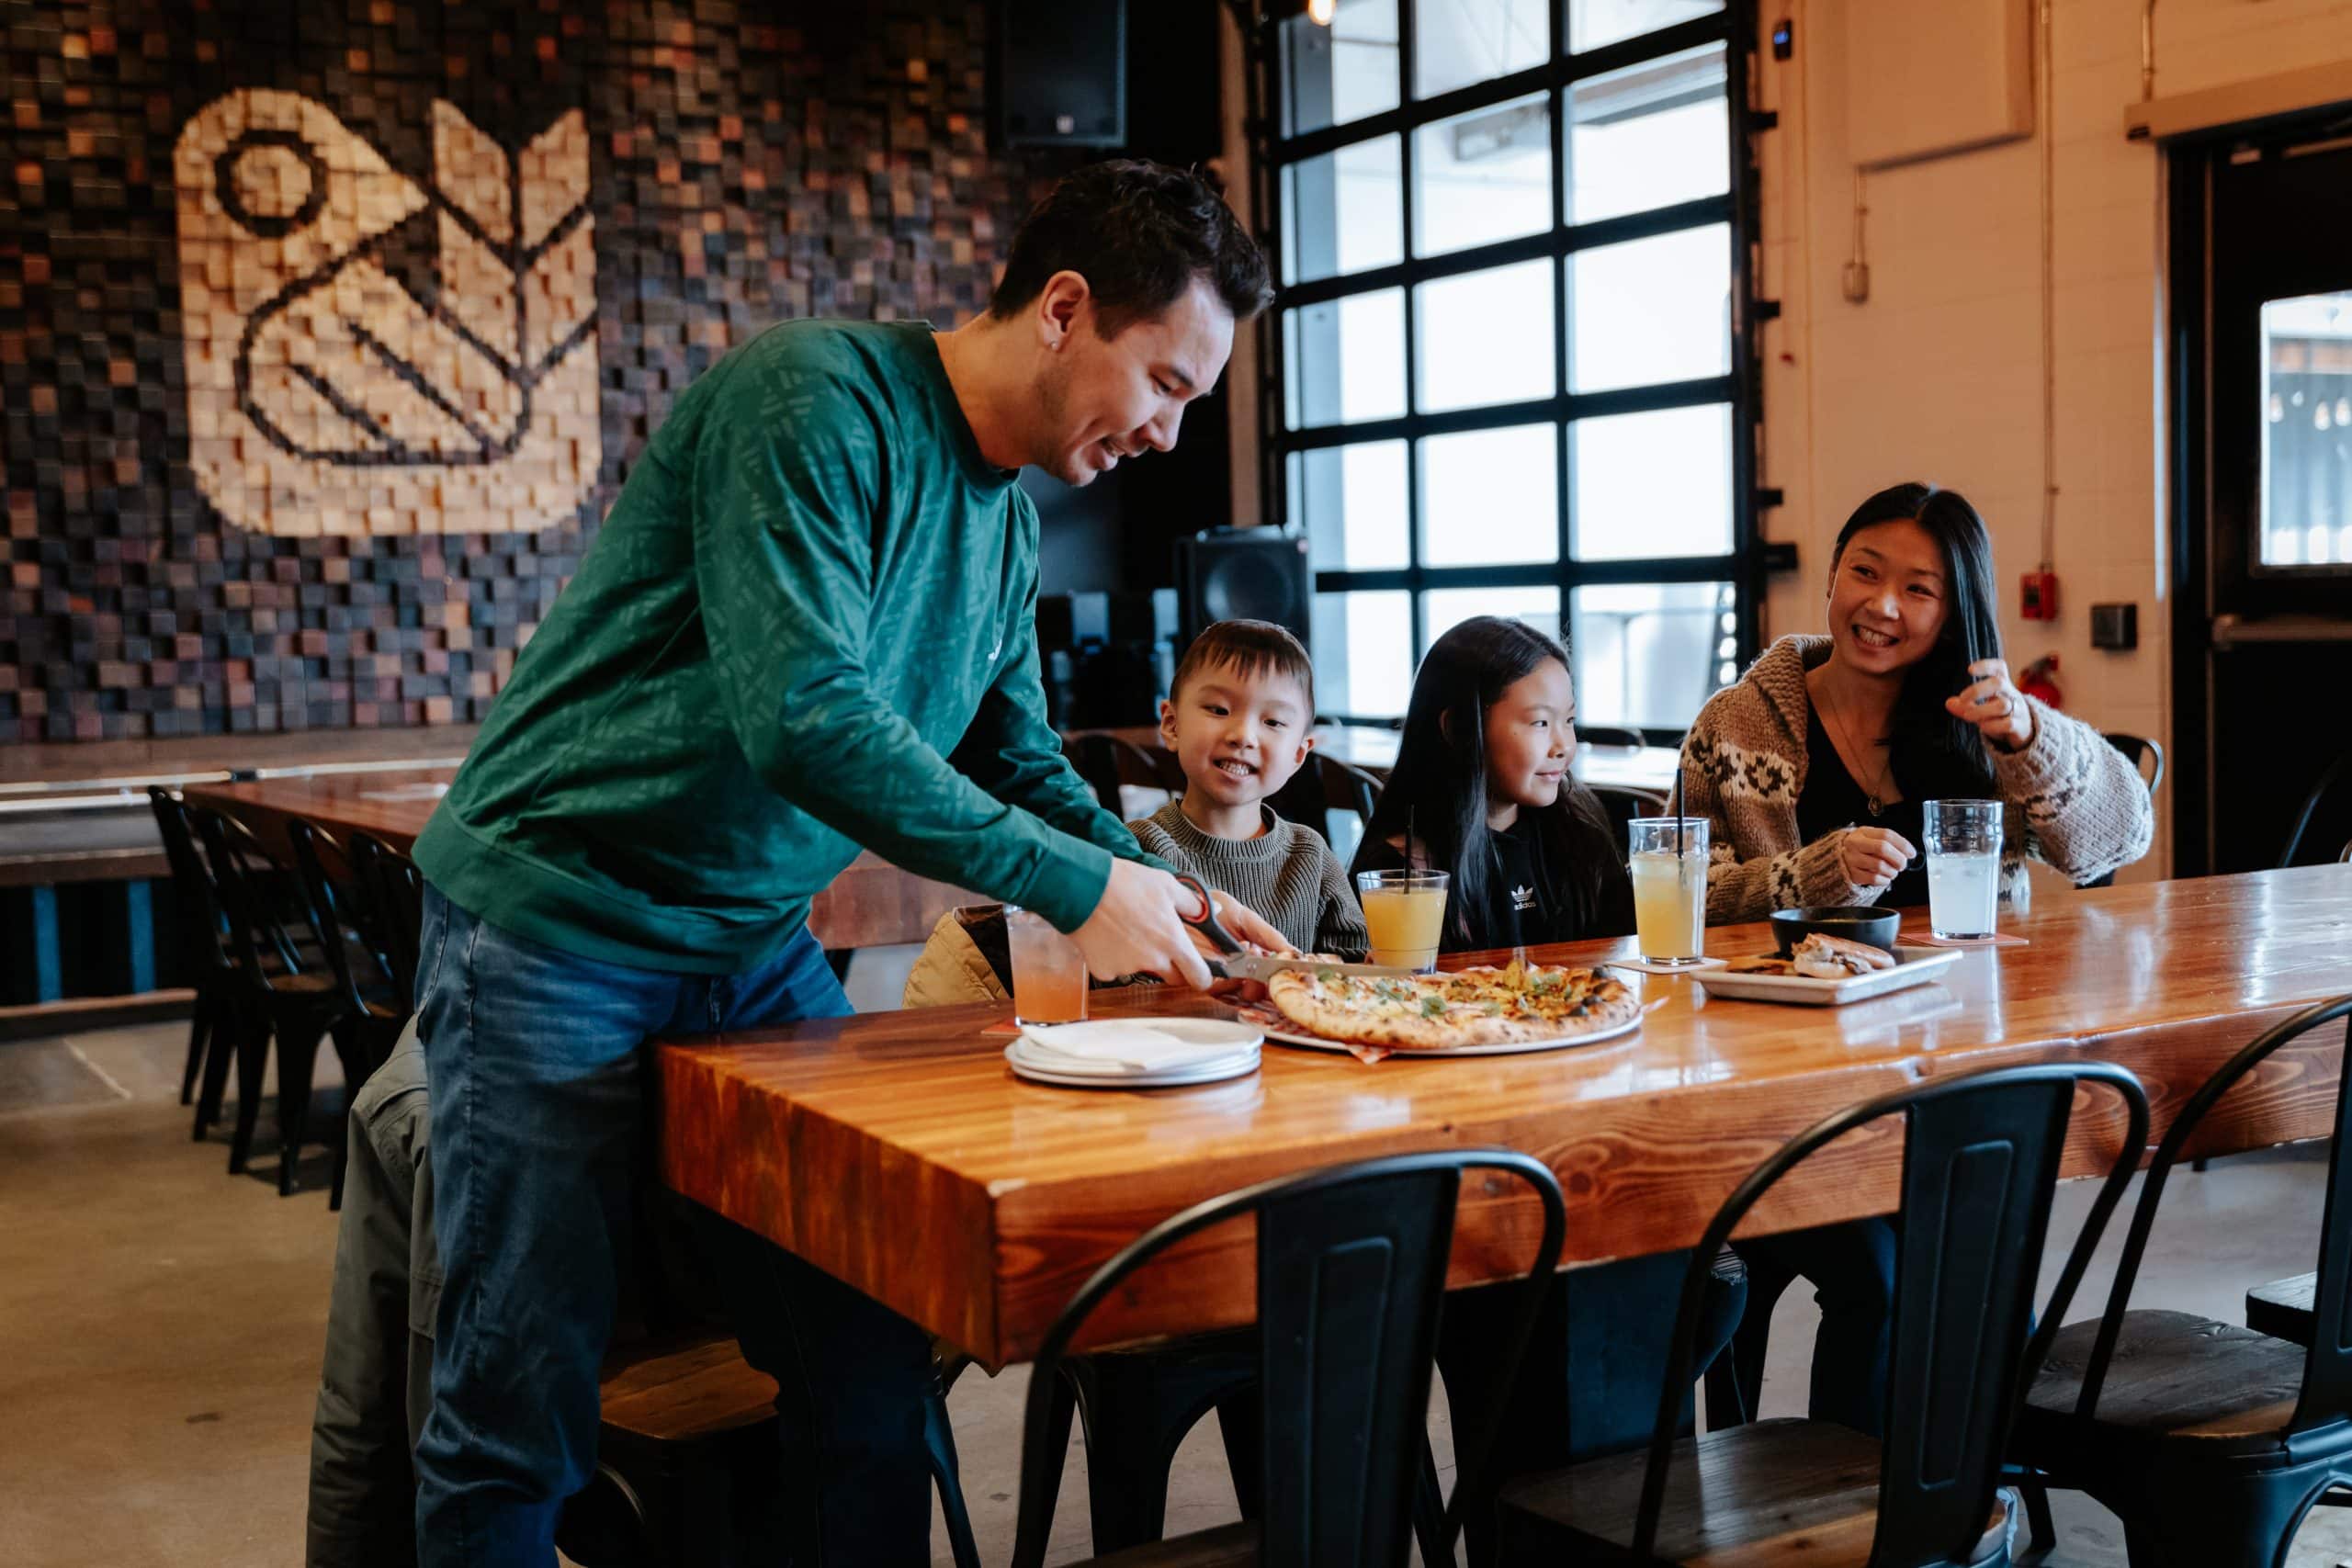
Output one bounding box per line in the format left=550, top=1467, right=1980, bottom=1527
left=184, top=769, right=978, bottom=950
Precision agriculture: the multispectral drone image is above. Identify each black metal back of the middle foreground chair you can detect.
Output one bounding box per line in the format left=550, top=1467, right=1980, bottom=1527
left=1633, top=1063, right=2147, bottom=1568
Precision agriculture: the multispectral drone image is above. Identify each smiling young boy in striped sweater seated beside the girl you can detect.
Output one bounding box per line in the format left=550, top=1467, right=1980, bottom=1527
left=1126, top=621, right=1366, bottom=959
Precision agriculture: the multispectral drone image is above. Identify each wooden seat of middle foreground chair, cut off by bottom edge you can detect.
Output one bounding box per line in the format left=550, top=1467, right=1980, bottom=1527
left=1500, top=1420, right=2016, bottom=1568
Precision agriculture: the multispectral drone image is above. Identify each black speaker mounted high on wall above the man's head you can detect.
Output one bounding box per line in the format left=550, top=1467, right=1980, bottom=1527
left=988, top=0, right=1126, bottom=148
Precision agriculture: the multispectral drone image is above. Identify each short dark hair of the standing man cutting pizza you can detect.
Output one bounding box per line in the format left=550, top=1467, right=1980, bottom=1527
left=988, top=157, right=1275, bottom=339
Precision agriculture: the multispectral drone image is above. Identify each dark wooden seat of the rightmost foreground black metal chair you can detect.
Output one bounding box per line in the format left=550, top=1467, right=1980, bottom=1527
left=2018, top=1312, right=2302, bottom=1460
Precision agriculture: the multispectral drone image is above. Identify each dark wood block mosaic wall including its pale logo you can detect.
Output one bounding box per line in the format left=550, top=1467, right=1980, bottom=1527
left=0, top=0, right=1070, bottom=740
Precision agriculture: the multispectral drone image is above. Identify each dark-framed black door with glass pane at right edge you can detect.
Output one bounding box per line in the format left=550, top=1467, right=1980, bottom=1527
left=2171, top=106, right=2352, bottom=877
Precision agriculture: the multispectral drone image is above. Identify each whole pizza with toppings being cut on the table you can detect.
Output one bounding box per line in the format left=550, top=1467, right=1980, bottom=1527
left=1265, top=964, right=1642, bottom=1051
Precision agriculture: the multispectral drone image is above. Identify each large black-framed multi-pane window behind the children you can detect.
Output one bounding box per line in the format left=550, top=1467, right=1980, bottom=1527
left=1259, top=0, right=1759, bottom=731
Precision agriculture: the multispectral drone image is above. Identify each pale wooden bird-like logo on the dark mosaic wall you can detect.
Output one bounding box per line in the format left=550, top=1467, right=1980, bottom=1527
left=174, top=87, right=602, bottom=545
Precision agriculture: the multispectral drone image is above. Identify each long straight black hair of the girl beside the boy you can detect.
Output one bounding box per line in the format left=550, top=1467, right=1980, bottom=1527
left=1357, top=616, right=1625, bottom=947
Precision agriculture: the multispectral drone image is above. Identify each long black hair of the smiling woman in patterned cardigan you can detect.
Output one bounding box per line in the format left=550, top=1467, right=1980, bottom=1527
left=1830, top=482, right=2002, bottom=799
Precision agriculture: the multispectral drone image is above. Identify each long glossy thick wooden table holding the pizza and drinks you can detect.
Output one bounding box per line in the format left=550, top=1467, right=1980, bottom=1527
left=656, top=867, right=2352, bottom=1366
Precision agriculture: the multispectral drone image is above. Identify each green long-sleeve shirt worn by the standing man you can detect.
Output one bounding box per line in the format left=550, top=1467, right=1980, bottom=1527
left=416, top=322, right=1166, bottom=974
